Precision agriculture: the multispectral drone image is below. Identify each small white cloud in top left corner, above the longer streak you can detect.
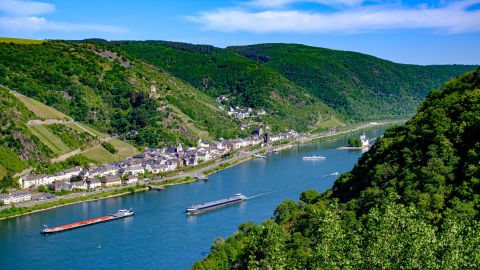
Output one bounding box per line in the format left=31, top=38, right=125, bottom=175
left=0, top=0, right=55, bottom=16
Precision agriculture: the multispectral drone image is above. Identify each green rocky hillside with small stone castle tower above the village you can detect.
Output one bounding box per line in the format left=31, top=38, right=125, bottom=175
left=0, top=41, right=241, bottom=151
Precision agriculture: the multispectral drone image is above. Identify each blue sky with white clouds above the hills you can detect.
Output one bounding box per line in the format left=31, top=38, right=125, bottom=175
left=0, top=0, right=480, bottom=65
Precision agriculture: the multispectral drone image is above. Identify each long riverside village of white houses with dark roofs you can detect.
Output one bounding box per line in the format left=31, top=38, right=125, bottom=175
left=0, top=130, right=300, bottom=205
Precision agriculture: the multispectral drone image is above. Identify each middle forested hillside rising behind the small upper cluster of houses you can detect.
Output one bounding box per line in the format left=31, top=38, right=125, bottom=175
left=112, top=41, right=333, bottom=131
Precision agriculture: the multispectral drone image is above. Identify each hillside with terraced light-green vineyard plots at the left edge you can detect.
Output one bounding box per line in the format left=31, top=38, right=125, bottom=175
left=0, top=87, right=138, bottom=184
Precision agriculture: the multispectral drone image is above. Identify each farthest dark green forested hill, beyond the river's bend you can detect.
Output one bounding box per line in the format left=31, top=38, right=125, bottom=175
left=228, top=44, right=475, bottom=120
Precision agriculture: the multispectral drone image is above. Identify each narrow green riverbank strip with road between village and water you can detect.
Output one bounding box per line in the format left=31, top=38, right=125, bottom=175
left=0, top=120, right=405, bottom=220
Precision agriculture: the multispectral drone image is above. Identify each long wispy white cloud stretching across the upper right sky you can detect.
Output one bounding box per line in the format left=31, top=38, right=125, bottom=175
left=189, top=0, right=480, bottom=34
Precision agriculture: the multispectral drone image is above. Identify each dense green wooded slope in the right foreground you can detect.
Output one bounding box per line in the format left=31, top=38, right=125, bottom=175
left=193, top=69, right=480, bottom=269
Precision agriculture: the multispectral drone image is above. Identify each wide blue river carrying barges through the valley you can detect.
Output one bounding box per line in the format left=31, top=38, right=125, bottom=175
left=0, top=128, right=384, bottom=270
